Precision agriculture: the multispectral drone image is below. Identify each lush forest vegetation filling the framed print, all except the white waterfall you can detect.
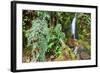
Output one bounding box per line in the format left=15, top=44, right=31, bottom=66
left=22, top=10, right=91, bottom=63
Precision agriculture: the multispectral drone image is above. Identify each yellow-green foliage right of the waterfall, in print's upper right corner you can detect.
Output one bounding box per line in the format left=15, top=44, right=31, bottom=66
left=77, top=13, right=91, bottom=41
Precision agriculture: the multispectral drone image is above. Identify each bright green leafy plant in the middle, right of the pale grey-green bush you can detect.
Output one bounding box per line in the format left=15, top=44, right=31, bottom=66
left=47, top=24, right=65, bottom=56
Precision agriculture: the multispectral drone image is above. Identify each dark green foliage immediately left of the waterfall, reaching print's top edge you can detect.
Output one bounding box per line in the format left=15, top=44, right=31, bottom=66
left=58, top=12, right=75, bottom=38
